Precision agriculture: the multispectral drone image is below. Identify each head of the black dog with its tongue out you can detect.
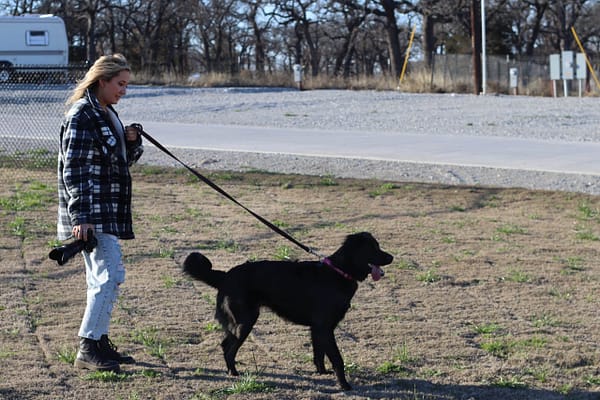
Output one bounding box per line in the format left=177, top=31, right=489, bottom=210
left=331, top=232, right=394, bottom=281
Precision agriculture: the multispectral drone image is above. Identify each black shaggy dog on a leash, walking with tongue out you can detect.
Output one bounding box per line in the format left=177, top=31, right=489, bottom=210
left=183, top=232, right=394, bottom=390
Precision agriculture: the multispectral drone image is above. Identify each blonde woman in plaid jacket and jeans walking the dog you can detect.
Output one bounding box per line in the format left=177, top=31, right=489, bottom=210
left=58, top=54, right=143, bottom=371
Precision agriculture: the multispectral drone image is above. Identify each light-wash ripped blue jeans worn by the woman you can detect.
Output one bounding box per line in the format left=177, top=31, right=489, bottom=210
left=79, top=233, right=125, bottom=340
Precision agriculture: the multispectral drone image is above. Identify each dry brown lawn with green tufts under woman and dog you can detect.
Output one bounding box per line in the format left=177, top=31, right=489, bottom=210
left=0, top=166, right=600, bottom=400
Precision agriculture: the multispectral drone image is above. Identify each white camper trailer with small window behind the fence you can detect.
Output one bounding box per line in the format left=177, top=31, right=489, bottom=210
left=0, top=14, right=69, bottom=83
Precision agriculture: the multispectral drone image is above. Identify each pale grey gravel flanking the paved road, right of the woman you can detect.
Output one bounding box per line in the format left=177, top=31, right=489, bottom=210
left=118, top=87, right=600, bottom=194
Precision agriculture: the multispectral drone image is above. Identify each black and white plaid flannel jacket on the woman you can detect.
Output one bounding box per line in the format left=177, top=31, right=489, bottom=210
left=57, top=91, right=143, bottom=240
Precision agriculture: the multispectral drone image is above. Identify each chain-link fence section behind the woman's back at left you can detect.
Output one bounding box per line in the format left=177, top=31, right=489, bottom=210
left=0, top=66, right=86, bottom=168
